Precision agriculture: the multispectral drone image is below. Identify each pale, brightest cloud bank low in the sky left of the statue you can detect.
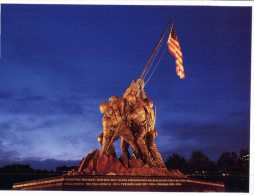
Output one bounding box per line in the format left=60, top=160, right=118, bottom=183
left=1, top=112, right=100, bottom=160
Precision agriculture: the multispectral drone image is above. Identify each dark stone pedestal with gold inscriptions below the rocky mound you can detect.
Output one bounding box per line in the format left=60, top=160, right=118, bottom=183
left=13, top=175, right=225, bottom=192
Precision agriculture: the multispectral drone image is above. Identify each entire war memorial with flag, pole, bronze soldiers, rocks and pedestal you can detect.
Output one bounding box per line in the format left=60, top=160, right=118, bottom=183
left=13, top=19, right=224, bottom=192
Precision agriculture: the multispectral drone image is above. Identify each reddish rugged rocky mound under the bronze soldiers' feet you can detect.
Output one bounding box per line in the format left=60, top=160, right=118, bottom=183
left=67, top=149, right=186, bottom=178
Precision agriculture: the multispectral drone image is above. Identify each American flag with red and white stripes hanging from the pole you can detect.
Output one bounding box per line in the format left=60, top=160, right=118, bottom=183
left=168, top=25, right=185, bottom=79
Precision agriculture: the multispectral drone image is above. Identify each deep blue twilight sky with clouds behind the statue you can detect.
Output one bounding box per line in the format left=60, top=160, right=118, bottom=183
left=0, top=4, right=251, bottom=167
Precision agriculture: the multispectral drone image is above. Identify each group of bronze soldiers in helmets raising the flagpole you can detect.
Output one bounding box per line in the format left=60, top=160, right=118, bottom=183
left=98, top=79, right=165, bottom=168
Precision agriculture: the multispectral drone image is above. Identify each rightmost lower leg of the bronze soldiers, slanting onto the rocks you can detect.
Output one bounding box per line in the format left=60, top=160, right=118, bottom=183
left=146, top=132, right=166, bottom=168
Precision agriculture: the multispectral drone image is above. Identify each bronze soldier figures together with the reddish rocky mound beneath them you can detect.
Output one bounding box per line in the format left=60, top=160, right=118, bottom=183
left=67, top=79, right=185, bottom=177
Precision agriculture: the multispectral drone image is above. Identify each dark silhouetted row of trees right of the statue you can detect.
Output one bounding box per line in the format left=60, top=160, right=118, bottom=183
left=165, top=149, right=249, bottom=176
